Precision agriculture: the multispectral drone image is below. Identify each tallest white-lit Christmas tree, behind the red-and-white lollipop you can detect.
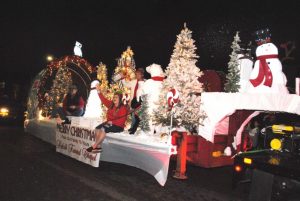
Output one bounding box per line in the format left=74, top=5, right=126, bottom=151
left=154, top=24, right=203, bottom=131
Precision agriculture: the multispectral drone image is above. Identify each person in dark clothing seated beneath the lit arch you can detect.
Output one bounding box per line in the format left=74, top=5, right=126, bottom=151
left=51, top=85, right=84, bottom=124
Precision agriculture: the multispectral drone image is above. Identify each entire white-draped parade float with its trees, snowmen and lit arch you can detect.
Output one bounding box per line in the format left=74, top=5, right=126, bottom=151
left=24, top=25, right=300, bottom=186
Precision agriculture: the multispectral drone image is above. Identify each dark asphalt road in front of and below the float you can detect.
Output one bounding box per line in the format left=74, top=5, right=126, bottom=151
left=0, top=125, right=248, bottom=201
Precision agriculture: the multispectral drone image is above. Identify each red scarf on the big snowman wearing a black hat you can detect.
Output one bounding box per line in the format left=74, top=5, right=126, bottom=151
left=250, top=54, right=278, bottom=87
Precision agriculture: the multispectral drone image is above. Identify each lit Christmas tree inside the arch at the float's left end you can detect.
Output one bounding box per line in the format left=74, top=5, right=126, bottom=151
left=42, top=66, right=72, bottom=116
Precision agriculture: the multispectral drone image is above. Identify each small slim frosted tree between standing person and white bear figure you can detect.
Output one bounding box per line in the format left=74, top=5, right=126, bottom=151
left=138, top=95, right=150, bottom=132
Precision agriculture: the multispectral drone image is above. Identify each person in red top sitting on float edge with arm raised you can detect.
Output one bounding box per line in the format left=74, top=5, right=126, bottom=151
left=86, top=88, right=128, bottom=152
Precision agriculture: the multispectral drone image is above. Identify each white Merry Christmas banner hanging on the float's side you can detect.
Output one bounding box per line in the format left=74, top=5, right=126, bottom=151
left=56, top=124, right=100, bottom=167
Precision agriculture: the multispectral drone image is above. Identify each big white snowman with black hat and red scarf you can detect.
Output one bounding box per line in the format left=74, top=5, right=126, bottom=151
left=247, top=29, right=289, bottom=94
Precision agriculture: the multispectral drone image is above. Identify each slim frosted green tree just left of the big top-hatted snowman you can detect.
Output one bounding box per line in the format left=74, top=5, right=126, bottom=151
left=224, top=32, right=241, bottom=93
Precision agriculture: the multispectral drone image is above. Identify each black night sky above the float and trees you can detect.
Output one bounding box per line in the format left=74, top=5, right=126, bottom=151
left=0, top=0, right=300, bottom=83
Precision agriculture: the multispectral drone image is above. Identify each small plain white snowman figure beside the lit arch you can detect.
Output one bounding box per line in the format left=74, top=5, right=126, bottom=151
left=84, top=80, right=103, bottom=118
